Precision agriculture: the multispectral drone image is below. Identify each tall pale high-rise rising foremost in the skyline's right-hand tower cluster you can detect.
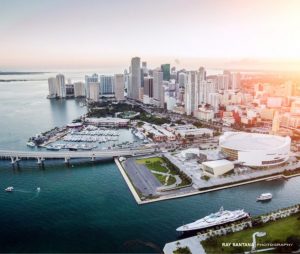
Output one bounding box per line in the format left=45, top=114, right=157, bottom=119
left=184, top=71, right=199, bottom=115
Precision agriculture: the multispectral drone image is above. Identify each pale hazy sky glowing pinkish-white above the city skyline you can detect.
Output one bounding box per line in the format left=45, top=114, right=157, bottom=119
left=0, top=0, right=300, bottom=70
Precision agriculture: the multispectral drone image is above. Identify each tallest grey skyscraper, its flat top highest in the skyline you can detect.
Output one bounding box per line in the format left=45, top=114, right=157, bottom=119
left=127, top=57, right=141, bottom=100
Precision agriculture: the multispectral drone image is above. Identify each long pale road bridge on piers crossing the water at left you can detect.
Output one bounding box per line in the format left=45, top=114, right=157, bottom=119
left=0, top=148, right=155, bottom=164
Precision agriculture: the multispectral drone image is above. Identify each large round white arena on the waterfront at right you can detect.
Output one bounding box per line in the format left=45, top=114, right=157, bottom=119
left=219, top=132, right=291, bottom=167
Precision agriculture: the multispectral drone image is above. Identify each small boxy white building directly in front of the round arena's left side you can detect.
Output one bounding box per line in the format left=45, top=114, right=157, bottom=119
left=202, top=160, right=234, bottom=177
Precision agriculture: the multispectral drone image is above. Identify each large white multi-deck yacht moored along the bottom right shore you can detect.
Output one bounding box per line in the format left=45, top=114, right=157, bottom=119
left=176, top=207, right=250, bottom=232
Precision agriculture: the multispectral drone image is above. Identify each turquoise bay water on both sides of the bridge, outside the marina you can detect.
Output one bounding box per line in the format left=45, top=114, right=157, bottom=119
left=0, top=73, right=300, bottom=253
